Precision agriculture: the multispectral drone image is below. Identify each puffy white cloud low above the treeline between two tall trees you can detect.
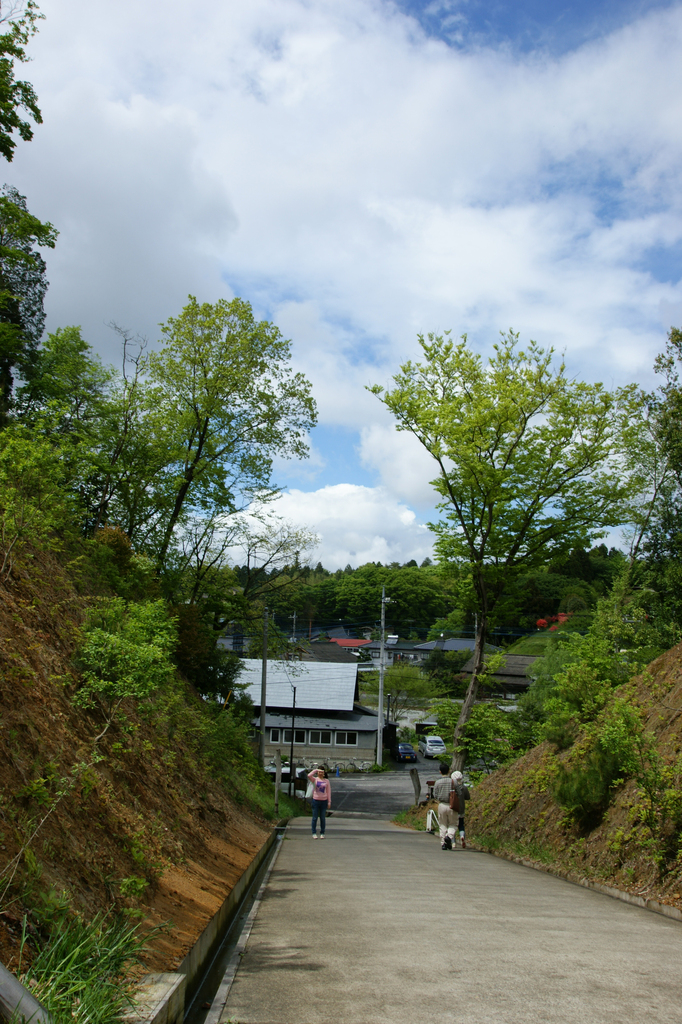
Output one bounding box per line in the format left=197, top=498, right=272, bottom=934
left=272, top=483, right=433, bottom=569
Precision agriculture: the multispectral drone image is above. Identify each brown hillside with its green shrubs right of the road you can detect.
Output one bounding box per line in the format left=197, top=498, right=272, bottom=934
left=467, top=644, right=682, bottom=907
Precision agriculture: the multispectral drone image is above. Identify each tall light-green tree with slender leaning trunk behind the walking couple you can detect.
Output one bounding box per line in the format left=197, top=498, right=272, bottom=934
left=371, top=332, right=629, bottom=768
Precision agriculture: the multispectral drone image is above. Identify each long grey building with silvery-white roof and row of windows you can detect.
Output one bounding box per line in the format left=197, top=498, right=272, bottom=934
left=239, top=658, right=378, bottom=764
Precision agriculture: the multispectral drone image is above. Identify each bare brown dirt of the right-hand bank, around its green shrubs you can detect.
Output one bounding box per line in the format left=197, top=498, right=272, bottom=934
left=467, top=644, right=682, bottom=908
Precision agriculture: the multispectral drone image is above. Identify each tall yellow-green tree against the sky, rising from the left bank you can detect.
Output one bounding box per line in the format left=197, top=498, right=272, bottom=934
left=147, top=296, right=316, bottom=566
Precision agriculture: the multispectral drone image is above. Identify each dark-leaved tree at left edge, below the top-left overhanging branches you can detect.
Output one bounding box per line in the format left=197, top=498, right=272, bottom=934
left=0, top=186, right=57, bottom=424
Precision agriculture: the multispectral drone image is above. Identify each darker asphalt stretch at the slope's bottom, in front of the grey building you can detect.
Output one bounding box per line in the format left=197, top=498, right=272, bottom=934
left=331, top=762, right=438, bottom=818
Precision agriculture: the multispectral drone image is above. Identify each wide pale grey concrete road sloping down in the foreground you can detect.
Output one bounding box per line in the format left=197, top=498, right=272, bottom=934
left=221, top=815, right=682, bottom=1024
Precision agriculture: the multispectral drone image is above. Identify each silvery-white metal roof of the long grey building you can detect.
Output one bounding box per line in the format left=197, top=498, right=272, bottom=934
left=239, top=657, right=357, bottom=711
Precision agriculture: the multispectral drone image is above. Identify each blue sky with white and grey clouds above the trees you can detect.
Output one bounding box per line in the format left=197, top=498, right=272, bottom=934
left=5, top=0, right=682, bottom=568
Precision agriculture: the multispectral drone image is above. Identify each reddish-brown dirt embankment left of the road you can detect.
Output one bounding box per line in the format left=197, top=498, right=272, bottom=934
left=0, top=555, right=271, bottom=971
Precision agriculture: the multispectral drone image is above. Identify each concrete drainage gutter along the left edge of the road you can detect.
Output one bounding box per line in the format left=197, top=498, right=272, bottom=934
left=127, top=828, right=278, bottom=1024
